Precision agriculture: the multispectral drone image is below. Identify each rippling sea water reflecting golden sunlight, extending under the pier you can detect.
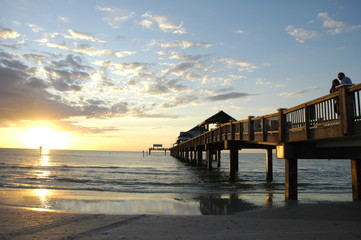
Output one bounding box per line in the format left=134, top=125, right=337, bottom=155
left=0, top=149, right=352, bottom=215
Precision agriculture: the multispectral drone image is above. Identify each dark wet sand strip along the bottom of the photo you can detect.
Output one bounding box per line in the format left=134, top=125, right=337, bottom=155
left=0, top=202, right=361, bottom=240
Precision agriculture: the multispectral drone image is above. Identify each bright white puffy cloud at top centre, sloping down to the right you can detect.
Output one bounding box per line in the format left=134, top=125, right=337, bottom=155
left=139, top=12, right=187, bottom=34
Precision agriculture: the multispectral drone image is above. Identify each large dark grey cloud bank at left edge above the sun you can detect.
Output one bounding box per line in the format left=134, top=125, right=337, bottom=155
left=0, top=62, right=80, bottom=121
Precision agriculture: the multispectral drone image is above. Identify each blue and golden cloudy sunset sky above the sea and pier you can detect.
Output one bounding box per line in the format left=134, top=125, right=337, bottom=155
left=0, top=0, right=361, bottom=151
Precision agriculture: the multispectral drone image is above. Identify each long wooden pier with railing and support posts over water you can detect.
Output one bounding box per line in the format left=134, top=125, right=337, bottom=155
left=170, top=84, right=361, bottom=200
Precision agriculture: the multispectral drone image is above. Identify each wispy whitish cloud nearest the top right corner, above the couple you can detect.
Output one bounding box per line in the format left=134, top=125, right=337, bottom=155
left=317, top=12, right=361, bottom=35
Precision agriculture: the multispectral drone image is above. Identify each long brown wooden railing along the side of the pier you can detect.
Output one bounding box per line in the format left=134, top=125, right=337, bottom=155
left=171, top=84, right=361, bottom=150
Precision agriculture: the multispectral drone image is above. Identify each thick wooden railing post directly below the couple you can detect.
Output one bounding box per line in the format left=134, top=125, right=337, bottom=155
left=338, top=85, right=354, bottom=135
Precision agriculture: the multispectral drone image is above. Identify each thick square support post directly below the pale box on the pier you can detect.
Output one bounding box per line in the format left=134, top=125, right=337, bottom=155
left=285, top=158, right=298, bottom=200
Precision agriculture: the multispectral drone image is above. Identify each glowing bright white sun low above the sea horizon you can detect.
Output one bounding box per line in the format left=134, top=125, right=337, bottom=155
left=21, top=126, right=70, bottom=149
